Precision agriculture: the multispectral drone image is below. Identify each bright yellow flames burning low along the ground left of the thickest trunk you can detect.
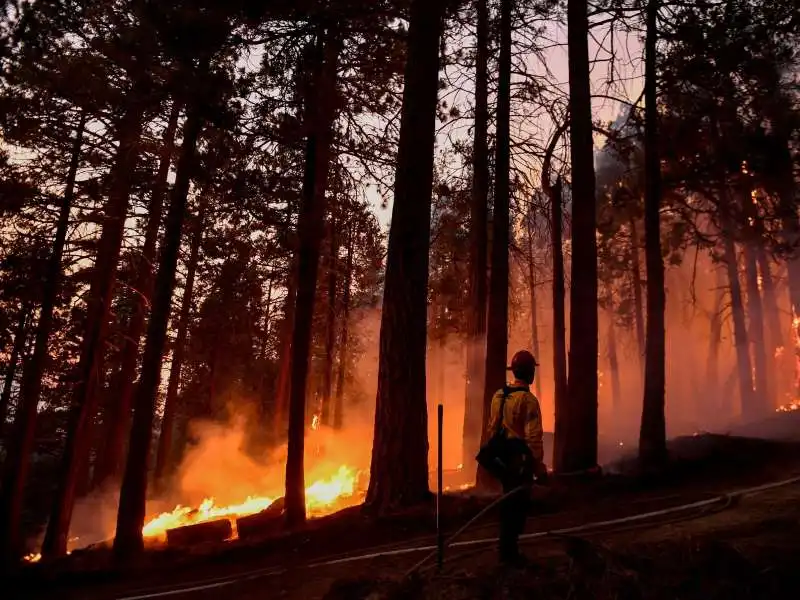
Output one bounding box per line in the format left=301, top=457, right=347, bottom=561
left=142, top=465, right=361, bottom=540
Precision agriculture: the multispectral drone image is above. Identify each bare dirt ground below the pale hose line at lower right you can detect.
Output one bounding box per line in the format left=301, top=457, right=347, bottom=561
left=322, top=485, right=800, bottom=600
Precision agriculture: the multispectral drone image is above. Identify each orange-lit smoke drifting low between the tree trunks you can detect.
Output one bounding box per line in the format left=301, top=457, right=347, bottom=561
left=64, top=254, right=794, bottom=546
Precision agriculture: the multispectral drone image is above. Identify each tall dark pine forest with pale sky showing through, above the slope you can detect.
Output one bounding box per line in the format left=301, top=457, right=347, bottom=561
left=0, top=0, right=800, bottom=563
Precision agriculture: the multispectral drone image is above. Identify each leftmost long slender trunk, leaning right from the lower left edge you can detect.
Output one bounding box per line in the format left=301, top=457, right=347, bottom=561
left=0, top=112, right=86, bottom=563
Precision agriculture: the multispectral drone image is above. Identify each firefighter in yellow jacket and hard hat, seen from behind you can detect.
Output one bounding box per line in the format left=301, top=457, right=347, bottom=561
left=489, top=350, right=547, bottom=565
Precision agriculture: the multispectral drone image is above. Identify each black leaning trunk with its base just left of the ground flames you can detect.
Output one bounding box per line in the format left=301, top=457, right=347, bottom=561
left=114, top=96, right=208, bottom=559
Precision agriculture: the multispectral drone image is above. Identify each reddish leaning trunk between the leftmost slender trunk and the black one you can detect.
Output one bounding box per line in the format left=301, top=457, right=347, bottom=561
left=42, top=102, right=144, bottom=557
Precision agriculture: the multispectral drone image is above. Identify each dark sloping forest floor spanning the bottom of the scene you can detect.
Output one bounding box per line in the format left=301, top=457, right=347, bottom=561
left=14, top=414, right=800, bottom=600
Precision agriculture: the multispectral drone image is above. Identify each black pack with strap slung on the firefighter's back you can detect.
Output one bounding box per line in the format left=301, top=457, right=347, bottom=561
left=475, top=386, right=534, bottom=482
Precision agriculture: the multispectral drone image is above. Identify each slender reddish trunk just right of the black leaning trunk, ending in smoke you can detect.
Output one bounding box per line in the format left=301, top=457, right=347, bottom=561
left=155, top=196, right=208, bottom=489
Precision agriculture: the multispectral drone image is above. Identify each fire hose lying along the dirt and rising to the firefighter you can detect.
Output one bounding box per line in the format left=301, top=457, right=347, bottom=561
left=116, top=476, right=800, bottom=600
